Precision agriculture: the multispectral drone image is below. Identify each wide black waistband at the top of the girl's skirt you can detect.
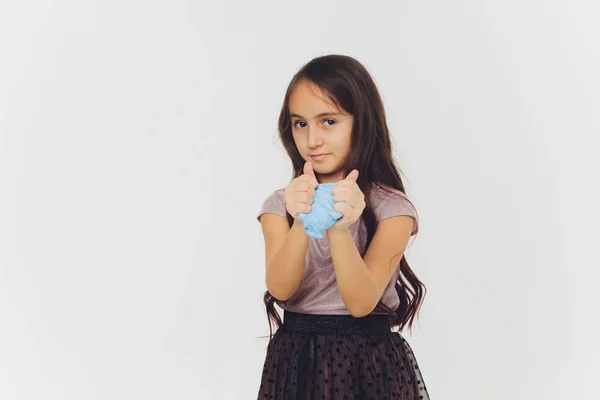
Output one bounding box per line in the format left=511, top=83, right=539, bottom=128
left=282, top=310, right=392, bottom=335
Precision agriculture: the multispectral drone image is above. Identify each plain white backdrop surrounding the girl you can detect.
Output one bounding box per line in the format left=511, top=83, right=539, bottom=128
left=0, top=0, right=600, bottom=400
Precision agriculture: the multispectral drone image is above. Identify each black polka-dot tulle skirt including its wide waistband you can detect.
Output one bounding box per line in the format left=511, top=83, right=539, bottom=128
left=258, top=311, right=429, bottom=400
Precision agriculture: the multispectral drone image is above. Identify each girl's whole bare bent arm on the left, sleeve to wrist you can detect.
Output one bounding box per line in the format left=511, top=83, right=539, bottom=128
left=261, top=214, right=309, bottom=301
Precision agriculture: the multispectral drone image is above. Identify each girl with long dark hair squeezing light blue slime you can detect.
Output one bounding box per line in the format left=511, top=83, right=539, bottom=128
left=258, top=55, right=429, bottom=400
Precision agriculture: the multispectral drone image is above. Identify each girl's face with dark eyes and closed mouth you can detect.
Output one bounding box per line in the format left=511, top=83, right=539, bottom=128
left=289, top=81, right=354, bottom=183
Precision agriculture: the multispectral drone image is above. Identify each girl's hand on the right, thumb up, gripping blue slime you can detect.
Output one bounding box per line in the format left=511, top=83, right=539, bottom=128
left=328, top=169, right=366, bottom=231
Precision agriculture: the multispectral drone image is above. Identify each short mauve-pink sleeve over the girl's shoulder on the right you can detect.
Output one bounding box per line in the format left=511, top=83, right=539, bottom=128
left=370, top=185, right=419, bottom=235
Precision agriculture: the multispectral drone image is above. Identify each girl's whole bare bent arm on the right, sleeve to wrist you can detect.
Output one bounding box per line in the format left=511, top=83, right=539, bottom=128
left=327, top=215, right=413, bottom=318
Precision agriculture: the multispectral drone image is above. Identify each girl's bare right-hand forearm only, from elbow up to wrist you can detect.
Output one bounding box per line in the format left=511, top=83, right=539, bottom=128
left=327, top=229, right=379, bottom=317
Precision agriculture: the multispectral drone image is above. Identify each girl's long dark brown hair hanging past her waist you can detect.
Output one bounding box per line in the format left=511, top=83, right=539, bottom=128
left=264, top=55, right=426, bottom=342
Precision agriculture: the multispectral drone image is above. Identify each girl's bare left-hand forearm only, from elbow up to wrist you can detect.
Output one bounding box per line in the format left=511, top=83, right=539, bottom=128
left=265, top=220, right=309, bottom=301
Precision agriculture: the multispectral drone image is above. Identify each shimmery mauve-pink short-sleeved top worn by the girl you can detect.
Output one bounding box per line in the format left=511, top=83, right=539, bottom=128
left=257, top=186, right=419, bottom=314
